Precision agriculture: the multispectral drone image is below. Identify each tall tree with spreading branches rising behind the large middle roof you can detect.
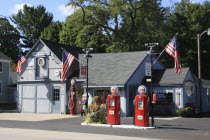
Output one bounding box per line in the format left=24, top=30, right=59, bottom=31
left=69, top=0, right=166, bottom=52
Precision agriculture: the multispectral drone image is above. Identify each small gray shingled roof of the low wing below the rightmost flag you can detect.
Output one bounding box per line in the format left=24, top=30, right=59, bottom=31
left=159, top=67, right=190, bottom=84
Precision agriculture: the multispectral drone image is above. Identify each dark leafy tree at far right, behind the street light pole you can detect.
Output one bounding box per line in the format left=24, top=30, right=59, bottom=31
left=164, top=0, right=210, bottom=79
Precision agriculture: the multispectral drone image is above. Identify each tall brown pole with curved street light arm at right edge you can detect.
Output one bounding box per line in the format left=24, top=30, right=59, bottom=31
left=197, top=28, right=210, bottom=113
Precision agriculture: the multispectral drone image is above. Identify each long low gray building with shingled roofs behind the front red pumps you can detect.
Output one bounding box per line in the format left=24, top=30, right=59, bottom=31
left=79, top=51, right=210, bottom=116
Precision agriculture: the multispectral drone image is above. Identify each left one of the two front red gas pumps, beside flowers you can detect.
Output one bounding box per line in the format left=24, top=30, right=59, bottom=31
left=106, top=86, right=120, bottom=124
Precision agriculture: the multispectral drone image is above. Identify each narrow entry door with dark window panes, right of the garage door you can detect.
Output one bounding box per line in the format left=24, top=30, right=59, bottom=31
left=52, top=86, right=60, bottom=114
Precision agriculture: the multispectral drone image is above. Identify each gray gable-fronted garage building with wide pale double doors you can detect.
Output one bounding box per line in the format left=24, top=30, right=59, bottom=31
left=17, top=39, right=82, bottom=114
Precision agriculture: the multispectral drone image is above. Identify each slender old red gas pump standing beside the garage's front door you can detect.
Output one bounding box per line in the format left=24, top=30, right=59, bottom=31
left=69, top=79, right=77, bottom=115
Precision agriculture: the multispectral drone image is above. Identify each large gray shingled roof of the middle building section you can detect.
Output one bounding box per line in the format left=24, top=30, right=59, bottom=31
left=79, top=51, right=147, bottom=86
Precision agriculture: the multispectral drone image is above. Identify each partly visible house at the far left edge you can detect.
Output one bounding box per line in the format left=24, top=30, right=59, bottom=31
left=0, top=52, right=11, bottom=103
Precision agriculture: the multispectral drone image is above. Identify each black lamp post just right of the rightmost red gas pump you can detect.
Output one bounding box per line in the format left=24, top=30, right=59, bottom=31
left=145, top=43, right=159, bottom=126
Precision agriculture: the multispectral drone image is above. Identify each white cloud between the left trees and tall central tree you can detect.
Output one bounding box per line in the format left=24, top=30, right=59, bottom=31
left=58, top=4, right=79, bottom=16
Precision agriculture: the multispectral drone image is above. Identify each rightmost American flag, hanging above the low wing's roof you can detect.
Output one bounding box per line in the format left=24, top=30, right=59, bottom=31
left=165, top=35, right=182, bottom=74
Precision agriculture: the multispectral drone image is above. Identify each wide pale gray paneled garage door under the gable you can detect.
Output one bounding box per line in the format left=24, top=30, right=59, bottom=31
left=22, top=84, right=51, bottom=113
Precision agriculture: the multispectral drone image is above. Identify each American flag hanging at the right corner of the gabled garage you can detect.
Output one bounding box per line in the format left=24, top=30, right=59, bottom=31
left=61, top=50, right=75, bottom=82
